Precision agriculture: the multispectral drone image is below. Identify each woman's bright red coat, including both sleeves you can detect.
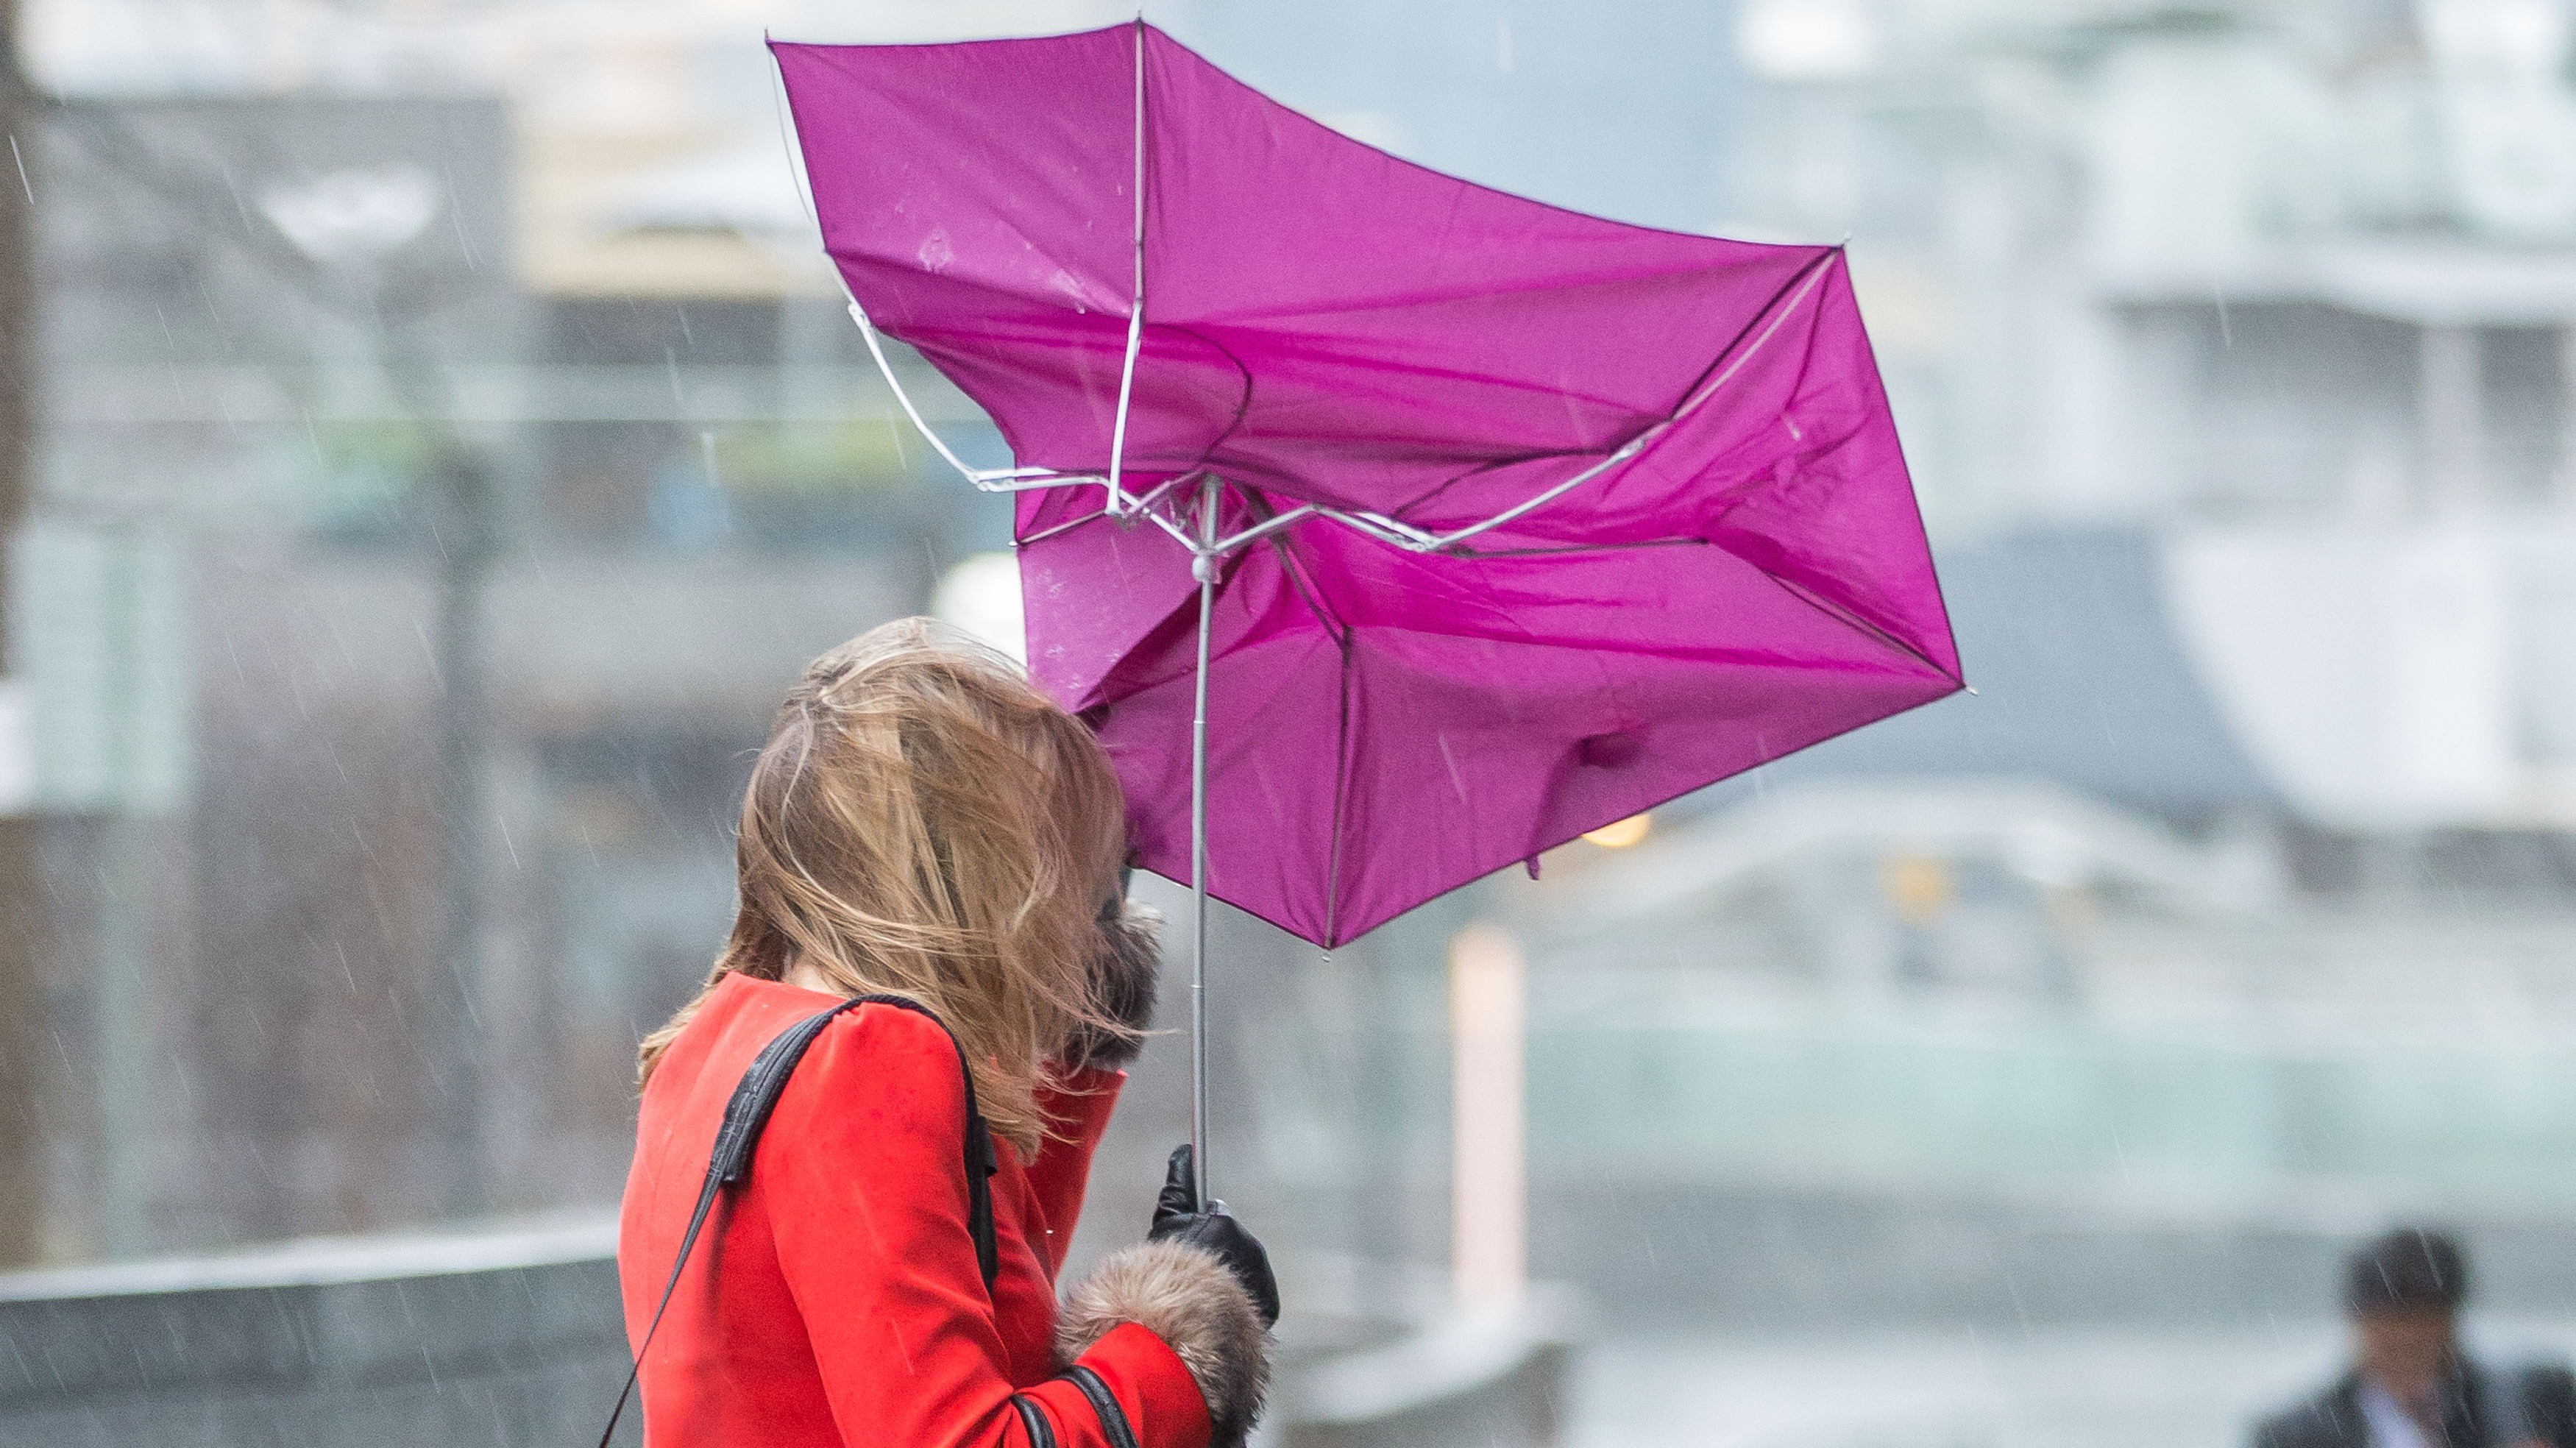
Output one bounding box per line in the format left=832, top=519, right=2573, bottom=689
left=618, top=974, right=1208, bottom=1448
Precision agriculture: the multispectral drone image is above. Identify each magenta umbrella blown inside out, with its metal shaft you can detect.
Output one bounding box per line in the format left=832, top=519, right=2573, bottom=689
left=773, top=21, right=1963, bottom=1195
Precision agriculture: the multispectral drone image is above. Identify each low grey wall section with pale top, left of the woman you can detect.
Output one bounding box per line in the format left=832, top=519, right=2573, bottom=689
left=0, top=1216, right=631, bottom=1448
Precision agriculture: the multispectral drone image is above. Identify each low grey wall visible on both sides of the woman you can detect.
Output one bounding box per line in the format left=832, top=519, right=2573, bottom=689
left=0, top=1213, right=1579, bottom=1448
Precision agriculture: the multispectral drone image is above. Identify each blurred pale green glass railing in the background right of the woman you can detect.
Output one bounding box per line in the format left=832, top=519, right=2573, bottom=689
left=1265, top=979, right=2576, bottom=1221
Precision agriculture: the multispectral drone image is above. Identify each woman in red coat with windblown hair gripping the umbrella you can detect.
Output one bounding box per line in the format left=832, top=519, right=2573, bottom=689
left=618, top=618, right=1277, bottom=1448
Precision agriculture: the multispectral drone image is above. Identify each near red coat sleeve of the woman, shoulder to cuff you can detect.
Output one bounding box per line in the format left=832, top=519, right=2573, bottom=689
left=752, top=1005, right=1208, bottom=1448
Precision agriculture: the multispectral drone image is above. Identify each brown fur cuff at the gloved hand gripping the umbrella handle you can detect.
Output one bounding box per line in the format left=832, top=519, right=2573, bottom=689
left=1056, top=1226, right=1270, bottom=1448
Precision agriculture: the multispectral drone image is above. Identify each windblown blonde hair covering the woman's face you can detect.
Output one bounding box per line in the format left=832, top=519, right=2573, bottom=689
left=642, top=618, right=1133, bottom=1154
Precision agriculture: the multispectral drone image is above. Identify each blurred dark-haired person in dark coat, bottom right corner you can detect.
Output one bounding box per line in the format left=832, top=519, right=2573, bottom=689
left=2252, top=1229, right=2576, bottom=1448
